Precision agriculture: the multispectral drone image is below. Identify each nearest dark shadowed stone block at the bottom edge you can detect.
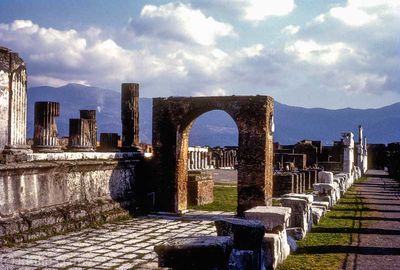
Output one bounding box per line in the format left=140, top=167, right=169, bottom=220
left=154, top=236, right=233, bottom=270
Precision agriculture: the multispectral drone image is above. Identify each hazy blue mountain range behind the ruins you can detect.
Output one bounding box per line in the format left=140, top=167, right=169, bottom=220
left=28, top=84, right=400, bottom=146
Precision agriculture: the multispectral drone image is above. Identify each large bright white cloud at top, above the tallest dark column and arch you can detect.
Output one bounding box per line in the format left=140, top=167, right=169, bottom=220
left=131, top=3, right=235, bottom=46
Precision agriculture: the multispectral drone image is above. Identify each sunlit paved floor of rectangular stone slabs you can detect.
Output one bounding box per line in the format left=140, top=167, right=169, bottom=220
left=0, top=211, right=233, bottom=269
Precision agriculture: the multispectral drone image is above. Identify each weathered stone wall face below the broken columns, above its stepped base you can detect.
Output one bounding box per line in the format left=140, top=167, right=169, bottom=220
left=0, top=160, right=138, bottom=223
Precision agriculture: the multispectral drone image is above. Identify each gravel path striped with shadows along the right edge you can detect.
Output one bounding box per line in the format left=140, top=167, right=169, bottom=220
left=343, top=171, right=400, bottom=270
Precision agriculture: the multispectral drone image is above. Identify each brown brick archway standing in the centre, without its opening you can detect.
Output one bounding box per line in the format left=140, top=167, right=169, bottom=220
left=153, top=96, right=274, bottom=215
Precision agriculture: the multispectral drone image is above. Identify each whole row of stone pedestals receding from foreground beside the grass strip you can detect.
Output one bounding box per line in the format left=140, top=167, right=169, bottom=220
left=155, top=169, right=361, bottom=269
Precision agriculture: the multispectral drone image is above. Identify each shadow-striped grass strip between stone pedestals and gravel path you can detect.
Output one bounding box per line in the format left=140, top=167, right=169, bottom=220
left=278, top=178, right=371, bottom=270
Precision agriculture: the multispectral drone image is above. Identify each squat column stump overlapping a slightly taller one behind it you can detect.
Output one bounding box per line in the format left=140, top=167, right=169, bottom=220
left=68, top=118, right=94, bottom=152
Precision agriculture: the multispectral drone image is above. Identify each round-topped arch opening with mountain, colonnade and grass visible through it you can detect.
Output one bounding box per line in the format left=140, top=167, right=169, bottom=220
left=187, top=110, right=239, bottom=212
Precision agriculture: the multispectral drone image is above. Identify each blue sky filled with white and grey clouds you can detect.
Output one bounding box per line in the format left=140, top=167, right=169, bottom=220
left=0, top=0, right=400, bottom=108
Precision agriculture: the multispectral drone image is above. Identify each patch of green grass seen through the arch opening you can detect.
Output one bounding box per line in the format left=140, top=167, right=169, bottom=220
left=189, top=184, right=237, bottom=212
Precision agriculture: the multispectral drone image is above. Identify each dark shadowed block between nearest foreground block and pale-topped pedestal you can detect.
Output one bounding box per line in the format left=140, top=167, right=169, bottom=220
left=215, top=218, right=265, bottom=250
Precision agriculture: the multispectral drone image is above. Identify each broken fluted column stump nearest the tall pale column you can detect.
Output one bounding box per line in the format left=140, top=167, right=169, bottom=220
left=32, top=101, right=61, bottom=153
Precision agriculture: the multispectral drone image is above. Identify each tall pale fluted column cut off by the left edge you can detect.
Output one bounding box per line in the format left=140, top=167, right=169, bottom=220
left=0, top=47, right=30, bottom=156
